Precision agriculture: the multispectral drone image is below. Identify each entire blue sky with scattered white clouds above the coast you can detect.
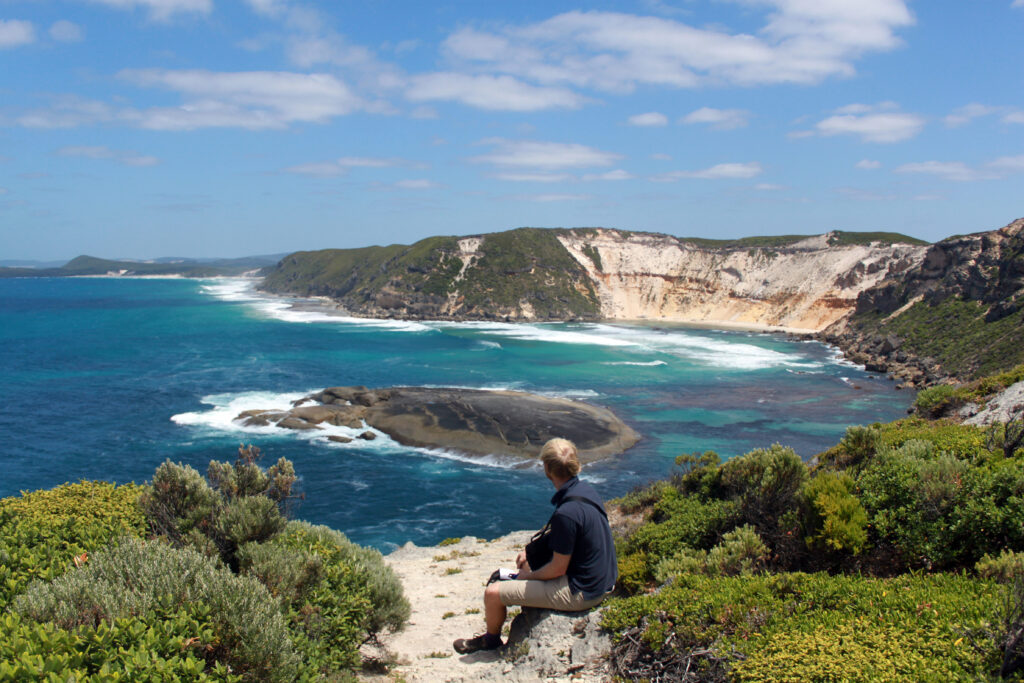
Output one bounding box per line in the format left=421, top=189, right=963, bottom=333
left=0, top=0, right=1024, bottom=260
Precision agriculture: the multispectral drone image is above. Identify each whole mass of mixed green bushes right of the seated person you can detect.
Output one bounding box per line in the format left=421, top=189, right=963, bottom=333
left=602, top=387, right=1024, bottom=681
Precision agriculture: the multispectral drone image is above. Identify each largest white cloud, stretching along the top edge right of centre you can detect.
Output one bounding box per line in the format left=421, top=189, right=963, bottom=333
left=444, top=0, right=913, bottom=92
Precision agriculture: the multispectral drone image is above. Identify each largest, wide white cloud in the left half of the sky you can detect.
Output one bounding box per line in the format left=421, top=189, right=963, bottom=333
left=119, top=69, right=365, bottom=130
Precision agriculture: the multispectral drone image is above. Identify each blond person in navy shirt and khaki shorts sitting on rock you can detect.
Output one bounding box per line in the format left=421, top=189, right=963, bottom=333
left=453, top=438, right=618, bottom=654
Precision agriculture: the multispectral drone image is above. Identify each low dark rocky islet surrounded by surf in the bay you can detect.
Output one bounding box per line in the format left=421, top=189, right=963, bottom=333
left=236, top=386, right=639, bottom=463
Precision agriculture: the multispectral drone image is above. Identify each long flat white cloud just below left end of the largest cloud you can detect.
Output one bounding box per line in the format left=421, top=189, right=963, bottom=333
left=406, top=72, right=587, bottom=112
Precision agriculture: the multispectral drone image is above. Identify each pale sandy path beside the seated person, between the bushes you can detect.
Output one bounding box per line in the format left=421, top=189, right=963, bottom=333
left=368, top=531, right=561, bottom=683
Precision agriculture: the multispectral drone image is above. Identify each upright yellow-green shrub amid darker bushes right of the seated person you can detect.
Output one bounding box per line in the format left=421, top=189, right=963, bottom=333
left=801, top=472, right=867, bottom=555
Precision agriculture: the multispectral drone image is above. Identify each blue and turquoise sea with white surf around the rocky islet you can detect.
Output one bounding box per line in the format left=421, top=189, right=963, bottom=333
left=0, top=279, right=911, bottom=551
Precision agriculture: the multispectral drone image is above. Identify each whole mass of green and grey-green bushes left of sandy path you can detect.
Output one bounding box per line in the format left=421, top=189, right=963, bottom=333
left=0, top=447, right=410, bottom=681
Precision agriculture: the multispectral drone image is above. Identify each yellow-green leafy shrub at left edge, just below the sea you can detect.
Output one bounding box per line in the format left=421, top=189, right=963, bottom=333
left=0, top=481, right=146, bottom=609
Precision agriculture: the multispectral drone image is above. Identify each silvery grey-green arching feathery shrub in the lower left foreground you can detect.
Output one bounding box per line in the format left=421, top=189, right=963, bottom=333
left=14, top=538, right=301, bottom=681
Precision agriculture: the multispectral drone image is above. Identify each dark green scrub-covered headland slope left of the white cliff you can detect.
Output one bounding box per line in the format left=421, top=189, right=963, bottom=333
left=262, top=227, right=600, bottom=319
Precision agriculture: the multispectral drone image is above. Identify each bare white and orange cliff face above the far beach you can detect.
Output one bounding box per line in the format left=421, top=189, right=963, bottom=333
left=559, top=229, right=927, bottom=332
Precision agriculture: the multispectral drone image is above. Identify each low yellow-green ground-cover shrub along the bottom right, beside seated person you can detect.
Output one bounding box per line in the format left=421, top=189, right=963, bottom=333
left=601, top=573, right=1004, bottom=681
